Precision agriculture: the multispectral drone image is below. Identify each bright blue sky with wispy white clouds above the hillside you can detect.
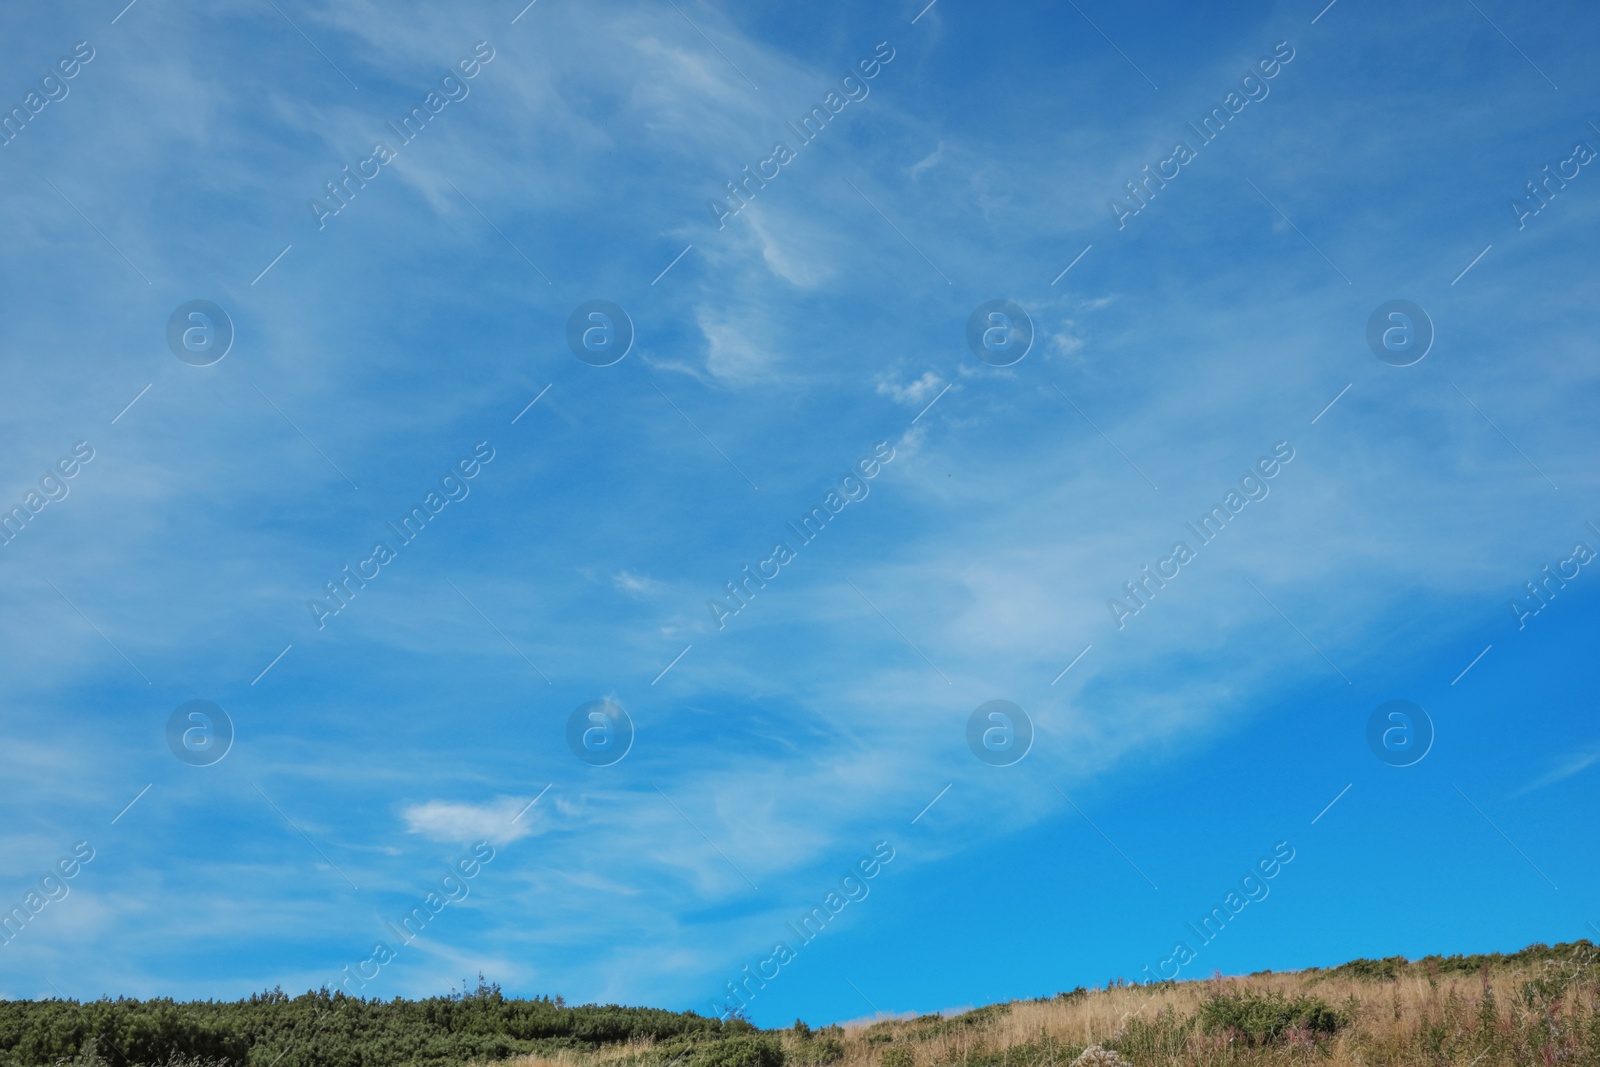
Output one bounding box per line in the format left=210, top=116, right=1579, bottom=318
left=0, top=0, right=1600, bottom=1025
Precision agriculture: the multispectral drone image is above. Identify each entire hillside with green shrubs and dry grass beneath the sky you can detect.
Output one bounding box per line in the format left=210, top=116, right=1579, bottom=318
left=0, top=941, right=1600, bottom=1067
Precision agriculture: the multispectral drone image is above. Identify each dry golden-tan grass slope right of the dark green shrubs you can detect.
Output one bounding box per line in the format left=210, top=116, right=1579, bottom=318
left=510, top=942, right=1600, bottom=1067
